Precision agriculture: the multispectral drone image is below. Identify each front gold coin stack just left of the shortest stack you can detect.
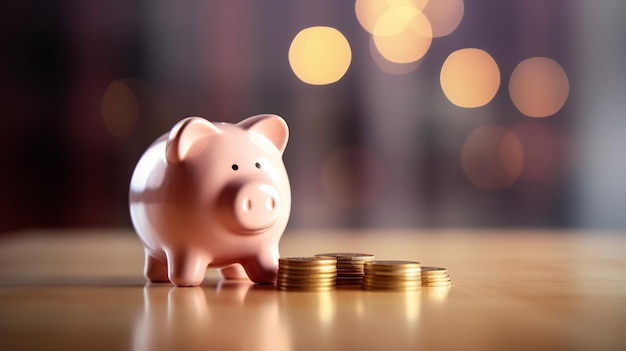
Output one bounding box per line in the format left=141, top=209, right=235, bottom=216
left=362, top=261, right=422, bottom=291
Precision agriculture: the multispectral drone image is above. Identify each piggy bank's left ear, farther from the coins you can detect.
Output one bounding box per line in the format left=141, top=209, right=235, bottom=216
left=165, top=117, right=220, bottom=163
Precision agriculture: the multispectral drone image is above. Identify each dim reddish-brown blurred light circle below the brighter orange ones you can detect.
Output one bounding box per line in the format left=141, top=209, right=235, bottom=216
left=461, top=126, right=524, bottom=190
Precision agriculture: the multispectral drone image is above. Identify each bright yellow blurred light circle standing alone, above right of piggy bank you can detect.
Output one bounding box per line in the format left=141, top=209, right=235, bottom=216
left=289, top=27, right=352, bottom=85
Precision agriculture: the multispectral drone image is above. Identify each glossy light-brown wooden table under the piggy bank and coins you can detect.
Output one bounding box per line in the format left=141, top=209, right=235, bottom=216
left=0, top=229, right=626, bottom=351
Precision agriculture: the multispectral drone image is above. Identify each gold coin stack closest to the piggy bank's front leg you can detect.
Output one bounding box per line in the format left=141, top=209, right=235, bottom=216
left=276, top=257, right=337, bottom=291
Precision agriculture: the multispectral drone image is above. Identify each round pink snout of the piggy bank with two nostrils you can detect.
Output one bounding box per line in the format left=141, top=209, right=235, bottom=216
left=219, top=181, right=280, bottom=233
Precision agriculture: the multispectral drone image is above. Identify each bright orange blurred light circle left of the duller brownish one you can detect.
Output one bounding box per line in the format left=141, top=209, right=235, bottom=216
left=440, top=48, right=500, bottom=108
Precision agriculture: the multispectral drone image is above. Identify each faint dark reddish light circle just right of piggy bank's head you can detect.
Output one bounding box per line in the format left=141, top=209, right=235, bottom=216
left=321, top=147, right=383, bottom=208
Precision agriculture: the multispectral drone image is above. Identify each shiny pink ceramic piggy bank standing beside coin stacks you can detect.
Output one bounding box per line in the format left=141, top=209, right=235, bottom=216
left=129, top=115, right=291, bottom=286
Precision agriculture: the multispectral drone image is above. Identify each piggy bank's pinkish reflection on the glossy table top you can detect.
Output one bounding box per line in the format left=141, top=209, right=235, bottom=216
left=132, top=281, right=292, bottom=351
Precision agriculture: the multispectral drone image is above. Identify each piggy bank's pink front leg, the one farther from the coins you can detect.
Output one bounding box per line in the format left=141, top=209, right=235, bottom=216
left=167, top=250, right=211, bottom=286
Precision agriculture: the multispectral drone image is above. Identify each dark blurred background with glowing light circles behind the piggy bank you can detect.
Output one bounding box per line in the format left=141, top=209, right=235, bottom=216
left=0, top=0, right=626, bottom=232
